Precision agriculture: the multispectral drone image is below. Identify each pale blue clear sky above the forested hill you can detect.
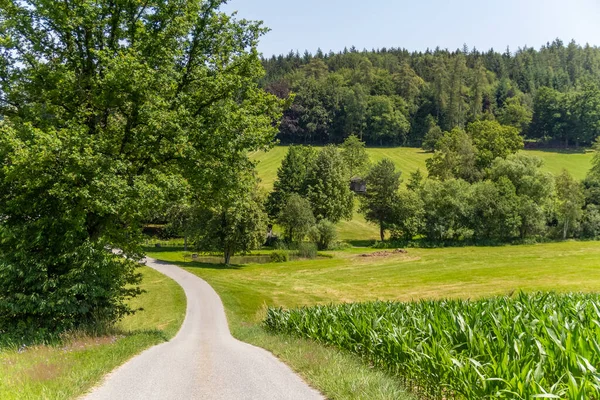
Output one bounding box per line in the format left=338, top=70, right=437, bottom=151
left=223, top=0, right=600, bottom=57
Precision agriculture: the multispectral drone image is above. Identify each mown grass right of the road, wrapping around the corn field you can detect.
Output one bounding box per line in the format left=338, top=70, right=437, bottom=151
left=148, top=241, right=600, bottom=399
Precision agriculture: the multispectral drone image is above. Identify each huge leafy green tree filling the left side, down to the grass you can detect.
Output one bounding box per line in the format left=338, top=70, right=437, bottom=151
left=0, top=0, right=282, bottom=332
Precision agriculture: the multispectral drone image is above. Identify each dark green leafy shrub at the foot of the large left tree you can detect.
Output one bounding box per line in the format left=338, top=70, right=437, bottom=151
left=0, top=242, right=141, bottom=343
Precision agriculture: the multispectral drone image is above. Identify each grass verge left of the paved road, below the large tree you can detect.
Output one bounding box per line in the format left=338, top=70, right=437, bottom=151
left=0, top=267, right=186, bottom=400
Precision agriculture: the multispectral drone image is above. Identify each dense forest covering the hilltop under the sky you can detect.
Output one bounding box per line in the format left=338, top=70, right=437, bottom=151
left=262, top=39, right=600, bottom=147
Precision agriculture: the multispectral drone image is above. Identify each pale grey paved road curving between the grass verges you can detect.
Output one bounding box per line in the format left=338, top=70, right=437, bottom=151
left=84, top=260, right=323, bottom=400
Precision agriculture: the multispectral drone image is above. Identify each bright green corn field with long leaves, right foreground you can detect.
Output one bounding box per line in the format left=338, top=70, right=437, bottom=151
left=264, top=293, right=600, bottom=400
